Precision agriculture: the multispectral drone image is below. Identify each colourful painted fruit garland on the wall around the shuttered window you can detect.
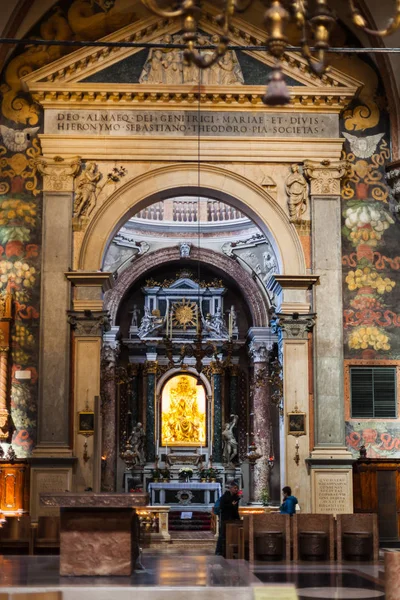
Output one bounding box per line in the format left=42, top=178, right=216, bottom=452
left=342, top=77, right=400, bottom=458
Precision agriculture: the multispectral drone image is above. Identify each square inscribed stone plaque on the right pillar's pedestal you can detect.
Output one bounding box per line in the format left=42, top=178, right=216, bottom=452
left=312, top=469, right=353, bottom=515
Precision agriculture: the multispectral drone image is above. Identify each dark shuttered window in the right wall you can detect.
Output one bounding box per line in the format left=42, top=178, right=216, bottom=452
left=350, top=367, right=397, bottom=419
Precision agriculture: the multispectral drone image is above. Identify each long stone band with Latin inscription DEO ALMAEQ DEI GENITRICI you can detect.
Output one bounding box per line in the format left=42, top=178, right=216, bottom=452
left=44, top=109, right=339, bottom=138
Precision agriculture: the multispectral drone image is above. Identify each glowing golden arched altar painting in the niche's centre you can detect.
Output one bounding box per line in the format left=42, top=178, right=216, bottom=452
left=161, top=375, right=206, bottom=446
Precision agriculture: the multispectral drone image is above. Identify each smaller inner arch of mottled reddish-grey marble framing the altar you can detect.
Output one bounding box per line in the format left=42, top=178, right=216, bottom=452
left=104, top=247, right=269, bottom=327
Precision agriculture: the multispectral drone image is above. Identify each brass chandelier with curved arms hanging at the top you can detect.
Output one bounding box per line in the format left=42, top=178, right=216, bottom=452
left=142, top=0, right=400, bottom=106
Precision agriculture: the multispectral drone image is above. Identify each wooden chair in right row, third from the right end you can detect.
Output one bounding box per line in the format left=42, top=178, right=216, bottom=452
left=249, top=513, right=290, bottom=563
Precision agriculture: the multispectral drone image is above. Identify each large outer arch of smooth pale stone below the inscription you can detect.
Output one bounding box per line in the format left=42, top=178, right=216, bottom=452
left=76, top=163, right=306, bottom=275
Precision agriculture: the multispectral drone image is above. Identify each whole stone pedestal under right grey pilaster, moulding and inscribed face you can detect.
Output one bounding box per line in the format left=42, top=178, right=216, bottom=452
left=307, top=446, right=354, bottom=515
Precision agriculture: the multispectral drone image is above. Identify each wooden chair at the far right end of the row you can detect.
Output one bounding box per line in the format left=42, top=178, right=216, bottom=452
left=336, top=513, right=379, bottom=562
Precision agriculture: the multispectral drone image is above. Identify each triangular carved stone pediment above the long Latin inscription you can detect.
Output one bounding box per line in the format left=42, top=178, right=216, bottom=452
left=24, top=5, right=362, bottom=112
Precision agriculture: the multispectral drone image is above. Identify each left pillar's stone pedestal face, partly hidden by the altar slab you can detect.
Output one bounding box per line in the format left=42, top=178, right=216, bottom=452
left=31, top=467, right=72, bottom=520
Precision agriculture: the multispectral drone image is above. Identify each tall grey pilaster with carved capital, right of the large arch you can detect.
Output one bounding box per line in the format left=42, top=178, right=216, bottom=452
left=304, top=161, right=348, bottom=454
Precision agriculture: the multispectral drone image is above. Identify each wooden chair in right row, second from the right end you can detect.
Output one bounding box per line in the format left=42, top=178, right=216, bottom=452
left=292, top=514, right=335, bottom=561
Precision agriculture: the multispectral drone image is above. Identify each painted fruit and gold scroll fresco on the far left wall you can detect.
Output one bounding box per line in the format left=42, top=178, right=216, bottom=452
left=0, top=0, right=138, bottom=457
